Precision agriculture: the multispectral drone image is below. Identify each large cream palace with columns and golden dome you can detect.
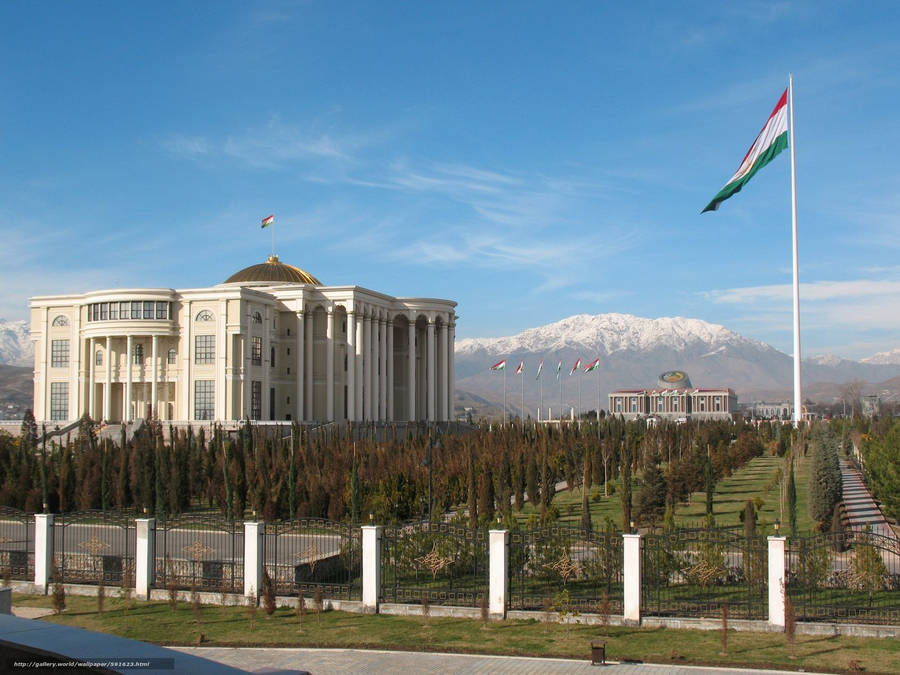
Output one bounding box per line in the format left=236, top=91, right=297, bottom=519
left=31, top=255, right=456, bottom=424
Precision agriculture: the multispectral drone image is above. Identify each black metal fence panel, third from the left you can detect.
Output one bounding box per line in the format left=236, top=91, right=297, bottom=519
left=154, top=514, right=244, bottom=593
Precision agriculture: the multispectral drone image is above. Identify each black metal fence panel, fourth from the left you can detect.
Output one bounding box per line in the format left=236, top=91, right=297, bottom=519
left=263, top=518, right=362, bottom=600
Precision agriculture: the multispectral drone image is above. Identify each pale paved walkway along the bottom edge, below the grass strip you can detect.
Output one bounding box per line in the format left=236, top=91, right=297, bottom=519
left=173, top=647, right=808, bottom=675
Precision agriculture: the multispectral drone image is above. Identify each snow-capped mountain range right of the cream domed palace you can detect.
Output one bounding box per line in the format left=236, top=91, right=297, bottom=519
left=455, top=314, right=900, bottom=415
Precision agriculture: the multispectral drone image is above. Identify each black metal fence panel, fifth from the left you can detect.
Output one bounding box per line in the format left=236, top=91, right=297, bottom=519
left=381, top=523, right=489, bottom=607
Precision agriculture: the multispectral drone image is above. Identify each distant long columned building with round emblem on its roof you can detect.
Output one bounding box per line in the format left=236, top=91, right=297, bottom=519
left=609, top=370, right=737, bottom=421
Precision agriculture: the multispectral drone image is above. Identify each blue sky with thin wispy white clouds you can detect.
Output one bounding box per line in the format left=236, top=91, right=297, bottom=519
left=0, top=1, right=900, bottom=358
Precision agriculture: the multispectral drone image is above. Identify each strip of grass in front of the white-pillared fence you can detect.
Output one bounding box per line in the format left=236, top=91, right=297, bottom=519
left=13, top=594, right=900, bottom=673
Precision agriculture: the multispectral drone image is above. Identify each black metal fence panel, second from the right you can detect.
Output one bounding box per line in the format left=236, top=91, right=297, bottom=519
left=641, top=529, right=768, bottom=619
